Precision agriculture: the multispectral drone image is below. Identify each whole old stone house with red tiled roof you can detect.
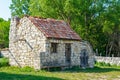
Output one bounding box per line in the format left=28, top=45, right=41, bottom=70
left=9, top=16, right=94, bottom=69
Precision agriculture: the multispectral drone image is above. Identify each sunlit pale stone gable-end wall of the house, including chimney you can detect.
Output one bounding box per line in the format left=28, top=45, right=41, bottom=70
left=9, top=17, right=46, bottom=69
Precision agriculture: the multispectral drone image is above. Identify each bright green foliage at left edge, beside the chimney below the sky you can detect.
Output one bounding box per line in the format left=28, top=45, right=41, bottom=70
left=0, top=19, right=10, bottom=48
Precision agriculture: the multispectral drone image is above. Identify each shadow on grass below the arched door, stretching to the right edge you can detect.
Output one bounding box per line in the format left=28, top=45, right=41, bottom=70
left=63, top=67, right=120, bottom=73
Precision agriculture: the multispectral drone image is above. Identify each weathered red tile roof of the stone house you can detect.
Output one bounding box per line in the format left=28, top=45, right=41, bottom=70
left=29, top=17, right=81, bottom=40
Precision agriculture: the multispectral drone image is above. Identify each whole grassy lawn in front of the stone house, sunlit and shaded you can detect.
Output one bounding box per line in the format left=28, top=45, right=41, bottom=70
left=0, top=63, right=120, bottom=80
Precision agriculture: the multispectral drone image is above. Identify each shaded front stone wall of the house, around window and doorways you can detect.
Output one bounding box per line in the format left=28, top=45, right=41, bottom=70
left=40, top=39, right=94, bottom=67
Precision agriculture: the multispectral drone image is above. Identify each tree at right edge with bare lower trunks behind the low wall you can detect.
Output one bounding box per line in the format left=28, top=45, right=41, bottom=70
left=103, top=0, right=120, bottom=56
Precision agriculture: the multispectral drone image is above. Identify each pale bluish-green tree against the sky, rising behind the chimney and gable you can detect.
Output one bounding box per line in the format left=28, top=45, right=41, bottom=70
left=10, top=0, right=30, bottom=17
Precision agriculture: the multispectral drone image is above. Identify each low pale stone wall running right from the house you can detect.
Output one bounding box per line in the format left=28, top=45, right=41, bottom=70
left=95, top=56, right=120, bottom=66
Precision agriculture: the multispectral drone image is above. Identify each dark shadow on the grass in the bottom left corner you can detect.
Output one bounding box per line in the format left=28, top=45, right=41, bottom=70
left=0, top=72, right=63, bottom=80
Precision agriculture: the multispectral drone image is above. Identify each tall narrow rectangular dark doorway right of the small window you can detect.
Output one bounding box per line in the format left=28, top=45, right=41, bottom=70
left=65, top=43, right=71, bottom=64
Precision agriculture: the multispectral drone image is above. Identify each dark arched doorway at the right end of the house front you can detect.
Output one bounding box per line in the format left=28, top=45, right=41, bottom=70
left=80, top=49, right=88, bottom=68
